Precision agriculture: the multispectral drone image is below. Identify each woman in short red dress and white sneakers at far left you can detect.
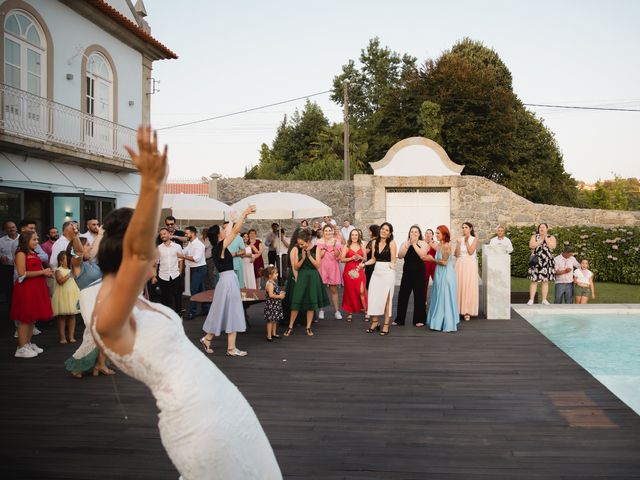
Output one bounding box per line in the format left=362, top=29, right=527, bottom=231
left=10, top=231, right=53, bottom=358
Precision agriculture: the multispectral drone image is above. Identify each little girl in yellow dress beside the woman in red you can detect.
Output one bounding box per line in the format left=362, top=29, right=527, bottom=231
left=51, top=250, right=80, bottom=343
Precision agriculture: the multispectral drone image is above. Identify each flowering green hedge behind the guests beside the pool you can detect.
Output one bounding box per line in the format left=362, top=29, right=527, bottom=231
left=506, top=225, right=640, bottom=285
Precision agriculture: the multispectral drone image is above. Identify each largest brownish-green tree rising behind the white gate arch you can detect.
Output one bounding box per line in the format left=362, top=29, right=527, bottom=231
left=424, top=38, right=577, bottom=205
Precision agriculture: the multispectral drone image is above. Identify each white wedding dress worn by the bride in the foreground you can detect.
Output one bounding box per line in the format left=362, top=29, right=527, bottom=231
left=92, top=298, right=282, bottom=480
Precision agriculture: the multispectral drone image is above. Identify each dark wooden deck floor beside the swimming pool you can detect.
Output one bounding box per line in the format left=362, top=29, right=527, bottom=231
left=0, top=292, right=640, bottom=480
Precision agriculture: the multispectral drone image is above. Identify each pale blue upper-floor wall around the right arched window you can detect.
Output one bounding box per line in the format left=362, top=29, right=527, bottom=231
left=18, top=0, right=143, bottom=128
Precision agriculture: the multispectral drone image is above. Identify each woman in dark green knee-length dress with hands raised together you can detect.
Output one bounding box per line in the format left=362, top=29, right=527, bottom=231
left=284, top=229, right=329, bottom=337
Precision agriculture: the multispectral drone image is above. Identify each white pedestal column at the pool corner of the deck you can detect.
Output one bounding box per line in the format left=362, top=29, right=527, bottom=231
left=482, top=245, right=511, bottom=320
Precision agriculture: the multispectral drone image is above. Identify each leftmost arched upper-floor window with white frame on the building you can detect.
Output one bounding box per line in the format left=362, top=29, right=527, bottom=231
left=4, top=10, right=47, bottom=96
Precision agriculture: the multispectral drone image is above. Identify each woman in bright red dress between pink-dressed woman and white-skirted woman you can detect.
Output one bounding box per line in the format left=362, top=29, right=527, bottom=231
left=340, top=229, right=367, bottom=322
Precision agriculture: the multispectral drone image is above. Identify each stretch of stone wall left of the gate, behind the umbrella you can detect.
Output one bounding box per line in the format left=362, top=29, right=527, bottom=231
left=214, top=178, right=354, bottom=236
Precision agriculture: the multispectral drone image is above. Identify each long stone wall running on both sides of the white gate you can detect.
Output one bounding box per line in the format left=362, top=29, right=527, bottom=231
left=210, top=175, right=640, bottom=246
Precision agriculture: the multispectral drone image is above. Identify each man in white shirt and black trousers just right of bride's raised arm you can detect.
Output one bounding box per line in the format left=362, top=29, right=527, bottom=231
left=151, top=227, right=183, bottom=314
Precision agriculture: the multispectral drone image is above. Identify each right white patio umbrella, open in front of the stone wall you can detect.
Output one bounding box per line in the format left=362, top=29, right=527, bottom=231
left=229, top=192, right=332, bottom=280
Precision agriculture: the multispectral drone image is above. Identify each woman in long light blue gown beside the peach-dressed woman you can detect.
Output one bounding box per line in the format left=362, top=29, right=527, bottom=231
left=426, top=225, right=460, bottom=332
